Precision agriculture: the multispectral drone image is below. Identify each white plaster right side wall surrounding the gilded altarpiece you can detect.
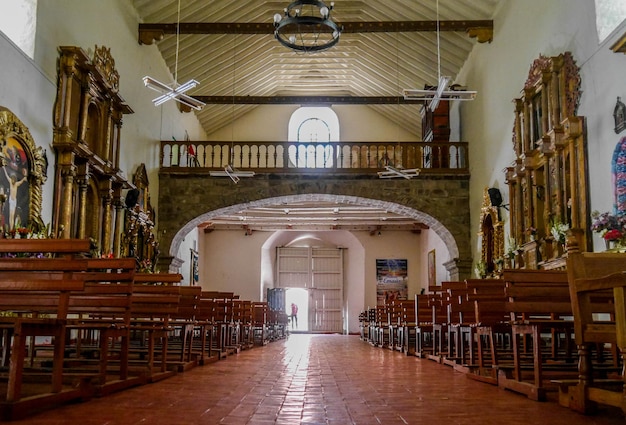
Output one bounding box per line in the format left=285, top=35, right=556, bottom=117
left=457, top=0, right=626, bottom=258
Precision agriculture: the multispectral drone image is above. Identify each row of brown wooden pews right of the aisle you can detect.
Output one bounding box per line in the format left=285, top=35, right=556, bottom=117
left=360, top=251, right=626, bottom=413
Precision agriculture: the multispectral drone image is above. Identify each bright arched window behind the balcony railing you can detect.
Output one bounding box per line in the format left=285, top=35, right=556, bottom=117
left=288, top=107, right=339, bottom=168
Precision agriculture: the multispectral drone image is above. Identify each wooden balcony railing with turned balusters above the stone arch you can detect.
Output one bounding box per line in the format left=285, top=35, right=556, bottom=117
left=161, top=141, right=469, bottom=175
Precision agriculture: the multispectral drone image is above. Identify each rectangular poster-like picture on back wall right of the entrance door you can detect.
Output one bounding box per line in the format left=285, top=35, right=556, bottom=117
left=376, top=259, right=409, bottom=305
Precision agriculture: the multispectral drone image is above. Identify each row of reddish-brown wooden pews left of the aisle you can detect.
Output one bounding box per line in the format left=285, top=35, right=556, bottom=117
left=0, top=239, right=287, bottom=420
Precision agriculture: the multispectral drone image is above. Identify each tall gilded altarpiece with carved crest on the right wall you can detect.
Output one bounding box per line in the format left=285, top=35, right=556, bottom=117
left=506, top=52, right=591, bottom=269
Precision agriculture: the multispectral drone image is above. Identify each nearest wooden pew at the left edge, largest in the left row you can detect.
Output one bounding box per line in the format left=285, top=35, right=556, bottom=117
left=0, top=239, right=90, bottom=420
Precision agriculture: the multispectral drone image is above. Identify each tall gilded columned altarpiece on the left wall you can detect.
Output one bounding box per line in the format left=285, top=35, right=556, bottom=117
left=52, top=46, right=133, bottom=255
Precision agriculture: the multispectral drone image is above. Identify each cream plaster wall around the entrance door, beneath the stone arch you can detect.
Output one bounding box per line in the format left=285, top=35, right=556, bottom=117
left=199, top=230, right=427, bottom=333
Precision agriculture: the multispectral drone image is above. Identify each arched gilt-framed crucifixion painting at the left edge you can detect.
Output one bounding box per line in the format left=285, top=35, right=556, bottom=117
left=0, top=107, right=48, bottom=233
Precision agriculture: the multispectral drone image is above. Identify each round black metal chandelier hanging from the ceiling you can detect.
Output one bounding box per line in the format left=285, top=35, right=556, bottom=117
left=274, top=0, right=343, bottom=53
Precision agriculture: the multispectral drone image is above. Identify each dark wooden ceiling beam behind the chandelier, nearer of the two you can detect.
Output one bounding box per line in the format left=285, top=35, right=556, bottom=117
left=139, top=20, right=493, bottom=44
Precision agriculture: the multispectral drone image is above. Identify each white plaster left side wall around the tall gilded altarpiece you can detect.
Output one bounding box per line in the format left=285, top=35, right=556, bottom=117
left=31, top=0, right=205, bottom=222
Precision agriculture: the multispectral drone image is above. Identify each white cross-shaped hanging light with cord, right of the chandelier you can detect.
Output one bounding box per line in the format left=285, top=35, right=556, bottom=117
left=402, top=0, right=476, bottom=112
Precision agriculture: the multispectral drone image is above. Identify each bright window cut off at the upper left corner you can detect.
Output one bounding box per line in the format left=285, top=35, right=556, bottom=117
left=0, top=0, right=37, bottom=59
